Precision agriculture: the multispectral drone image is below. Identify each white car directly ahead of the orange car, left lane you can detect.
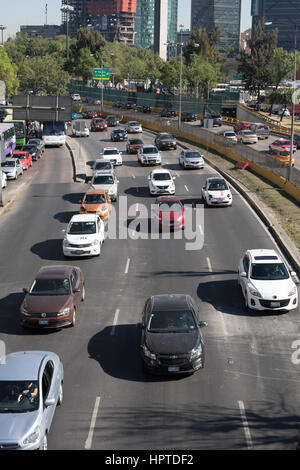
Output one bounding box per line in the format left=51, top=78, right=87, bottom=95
left=63, top=214, right=104, bottom=256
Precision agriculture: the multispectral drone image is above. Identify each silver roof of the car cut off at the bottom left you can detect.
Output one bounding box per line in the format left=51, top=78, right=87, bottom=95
left=0, top=351, right=56, bottom=381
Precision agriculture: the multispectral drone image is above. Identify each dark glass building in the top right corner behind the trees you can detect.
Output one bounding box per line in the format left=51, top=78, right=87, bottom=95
left=251, top=0, right=300, bottom=50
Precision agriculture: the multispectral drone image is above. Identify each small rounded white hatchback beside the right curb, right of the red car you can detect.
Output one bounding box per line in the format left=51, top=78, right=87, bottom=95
left=202, top=176, right=232, bottom=206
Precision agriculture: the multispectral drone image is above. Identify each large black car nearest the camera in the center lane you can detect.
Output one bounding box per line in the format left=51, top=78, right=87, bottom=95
left=137, top=294, right=207, bottom=374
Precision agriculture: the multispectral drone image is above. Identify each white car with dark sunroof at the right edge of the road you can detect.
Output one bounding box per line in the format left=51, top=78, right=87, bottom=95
left=238, top=249, right=298, bottom=311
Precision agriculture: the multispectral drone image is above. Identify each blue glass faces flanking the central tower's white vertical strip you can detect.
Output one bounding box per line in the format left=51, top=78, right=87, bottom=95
left=135, top=0, right=178, bottom=50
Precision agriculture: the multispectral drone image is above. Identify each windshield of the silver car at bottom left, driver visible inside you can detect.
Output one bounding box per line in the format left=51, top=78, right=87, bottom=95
left=0, top=380, right=39, bottom=413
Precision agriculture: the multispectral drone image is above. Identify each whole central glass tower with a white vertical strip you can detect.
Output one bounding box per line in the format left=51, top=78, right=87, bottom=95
left=135, top=0, right=178, bottom=59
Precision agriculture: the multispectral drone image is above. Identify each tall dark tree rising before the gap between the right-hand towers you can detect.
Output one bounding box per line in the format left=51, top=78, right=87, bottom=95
left=238, top=18, right=277, bottom=105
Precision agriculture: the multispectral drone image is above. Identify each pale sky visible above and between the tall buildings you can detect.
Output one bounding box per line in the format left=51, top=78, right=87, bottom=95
left=0, top=0, right=251, bottom=41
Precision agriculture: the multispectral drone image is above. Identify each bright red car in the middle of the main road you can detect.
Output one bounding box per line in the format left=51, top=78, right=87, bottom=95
left=154, top=196, right=185, bottom=231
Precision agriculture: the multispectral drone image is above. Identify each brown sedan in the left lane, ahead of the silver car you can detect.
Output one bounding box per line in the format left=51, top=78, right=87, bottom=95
left=20, top=265, right=85, bottom=328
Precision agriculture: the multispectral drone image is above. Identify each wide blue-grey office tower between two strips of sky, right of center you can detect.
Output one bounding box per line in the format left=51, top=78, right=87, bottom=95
left=191, top=0, right=241, bottom=50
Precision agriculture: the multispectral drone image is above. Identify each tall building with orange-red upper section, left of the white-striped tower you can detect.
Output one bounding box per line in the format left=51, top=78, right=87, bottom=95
left=62, top=0, right=137, bottom=45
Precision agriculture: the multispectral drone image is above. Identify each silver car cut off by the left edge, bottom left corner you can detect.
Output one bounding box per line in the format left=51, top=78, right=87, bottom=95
left=0, top=351, right=64, bottom=450
